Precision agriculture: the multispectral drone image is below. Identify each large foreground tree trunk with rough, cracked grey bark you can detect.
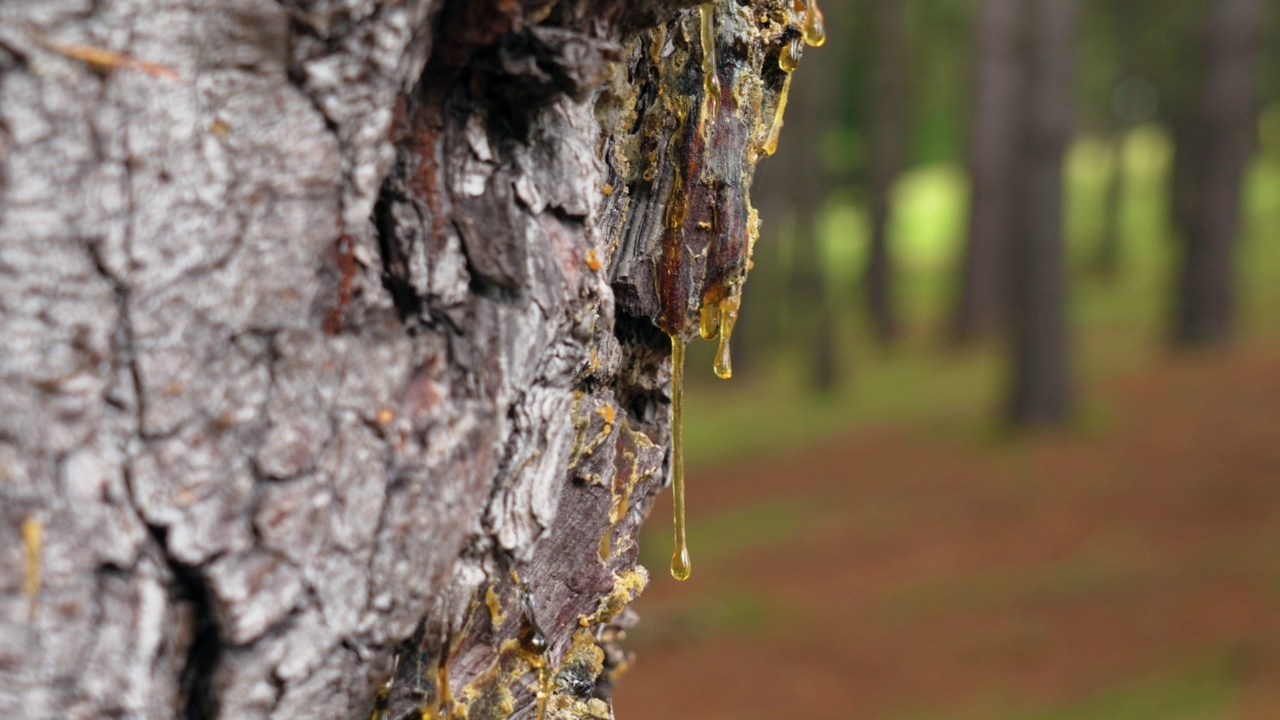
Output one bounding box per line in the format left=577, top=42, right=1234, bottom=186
left=0, top=0, right=803, bottom=719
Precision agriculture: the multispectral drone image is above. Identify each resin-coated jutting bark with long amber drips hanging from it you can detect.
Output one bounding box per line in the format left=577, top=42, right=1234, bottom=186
left=616, top=0, right=823, bottom=579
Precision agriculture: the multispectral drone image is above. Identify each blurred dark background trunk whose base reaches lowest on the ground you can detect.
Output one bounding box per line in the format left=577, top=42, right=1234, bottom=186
left=1010, top=0, right=1078, bottom=425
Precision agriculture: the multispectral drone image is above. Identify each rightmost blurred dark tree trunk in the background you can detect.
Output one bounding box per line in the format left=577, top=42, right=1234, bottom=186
left=1174, top=0, right=1266, bottom=346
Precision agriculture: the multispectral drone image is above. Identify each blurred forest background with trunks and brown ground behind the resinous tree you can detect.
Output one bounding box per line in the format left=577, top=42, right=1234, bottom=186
left=616, top=0, right=1280, bottom=720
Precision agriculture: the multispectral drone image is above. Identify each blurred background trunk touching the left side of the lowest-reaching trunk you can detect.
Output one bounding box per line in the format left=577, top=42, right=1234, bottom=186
left=952, top=0, right=1027, bottom=343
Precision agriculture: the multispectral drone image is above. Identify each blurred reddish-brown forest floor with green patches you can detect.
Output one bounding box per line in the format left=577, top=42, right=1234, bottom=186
left=616, top=348, right=1280, bottom=720
